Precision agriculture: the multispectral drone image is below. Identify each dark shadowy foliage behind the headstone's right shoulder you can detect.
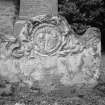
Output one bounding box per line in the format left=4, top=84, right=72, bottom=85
left=58, top=0, right=105, bottom=52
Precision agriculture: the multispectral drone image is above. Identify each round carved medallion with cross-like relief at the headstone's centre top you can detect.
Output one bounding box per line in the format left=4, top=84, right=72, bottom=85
left=33, top=25, right=61, bottom=55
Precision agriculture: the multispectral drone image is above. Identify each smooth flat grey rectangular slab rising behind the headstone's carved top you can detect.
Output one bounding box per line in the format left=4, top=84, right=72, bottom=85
left=20, top=0, right=58, bottom=17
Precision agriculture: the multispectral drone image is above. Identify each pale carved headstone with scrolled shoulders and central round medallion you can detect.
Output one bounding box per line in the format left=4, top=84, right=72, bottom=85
left=0, top=15, right=101, bottom=91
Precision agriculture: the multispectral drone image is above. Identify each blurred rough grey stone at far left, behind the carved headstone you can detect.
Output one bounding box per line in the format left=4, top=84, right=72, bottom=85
left=0, top=0, right=15, bottom=37
